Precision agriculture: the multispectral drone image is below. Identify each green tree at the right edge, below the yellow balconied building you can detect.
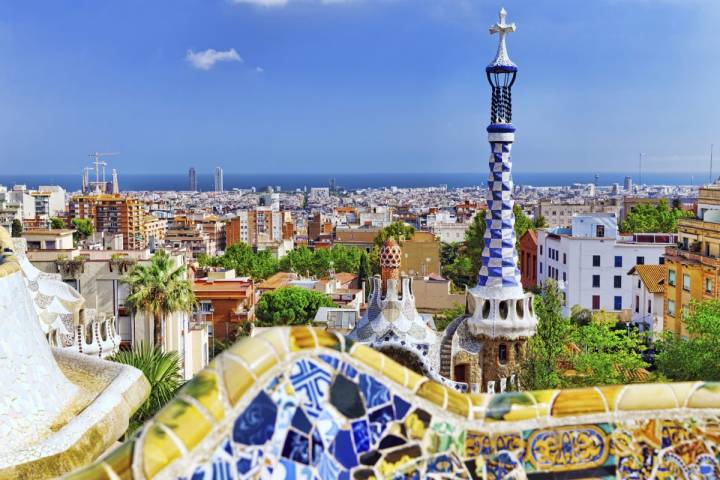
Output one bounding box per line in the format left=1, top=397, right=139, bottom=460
left=655, top=299, right=720, bottom=381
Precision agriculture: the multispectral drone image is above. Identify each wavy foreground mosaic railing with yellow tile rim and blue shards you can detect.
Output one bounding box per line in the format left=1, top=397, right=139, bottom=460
left=70, top=327, right=720, bottom=480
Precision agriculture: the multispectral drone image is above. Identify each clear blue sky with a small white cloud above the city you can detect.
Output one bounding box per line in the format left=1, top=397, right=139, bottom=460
left=0, top=0, right=720, bottom=174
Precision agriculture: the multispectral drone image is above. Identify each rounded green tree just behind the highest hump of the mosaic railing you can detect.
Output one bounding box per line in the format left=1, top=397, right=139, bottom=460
left=255, top=287, right=335, bottom=327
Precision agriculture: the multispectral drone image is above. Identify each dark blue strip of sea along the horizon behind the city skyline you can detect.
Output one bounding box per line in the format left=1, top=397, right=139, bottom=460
left=0, top=171, right=709, bottom=191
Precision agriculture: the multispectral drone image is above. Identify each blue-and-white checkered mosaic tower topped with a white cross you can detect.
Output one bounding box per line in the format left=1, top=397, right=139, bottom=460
left=468, top=9, right=537, bottom=390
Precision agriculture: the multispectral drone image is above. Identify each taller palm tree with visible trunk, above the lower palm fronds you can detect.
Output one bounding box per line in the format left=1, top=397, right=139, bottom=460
left=124, top=250, right=195, bottom=347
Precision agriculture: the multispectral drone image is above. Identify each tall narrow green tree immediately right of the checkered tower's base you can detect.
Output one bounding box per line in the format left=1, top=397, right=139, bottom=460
left=521, top=280, right=573, bottom=390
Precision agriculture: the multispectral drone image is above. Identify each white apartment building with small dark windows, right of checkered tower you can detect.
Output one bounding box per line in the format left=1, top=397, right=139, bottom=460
left=537, top=213, right=676, bottom=320
